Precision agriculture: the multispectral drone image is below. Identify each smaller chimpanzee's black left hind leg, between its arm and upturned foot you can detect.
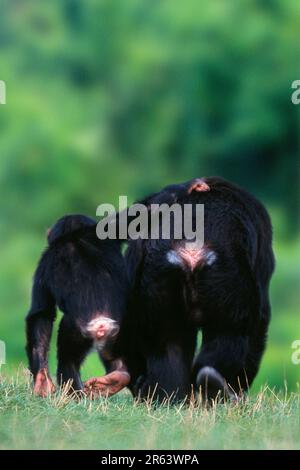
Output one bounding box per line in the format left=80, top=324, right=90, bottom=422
left=57, top=318, right=92, bottom=390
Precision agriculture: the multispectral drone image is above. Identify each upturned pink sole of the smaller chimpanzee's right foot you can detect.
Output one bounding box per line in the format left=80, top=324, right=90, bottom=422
left=84, top=370, right=130, bottom=398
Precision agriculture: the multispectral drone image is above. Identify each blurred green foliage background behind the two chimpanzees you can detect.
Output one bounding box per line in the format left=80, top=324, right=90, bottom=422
left=0, top=0, right=300, bottom=390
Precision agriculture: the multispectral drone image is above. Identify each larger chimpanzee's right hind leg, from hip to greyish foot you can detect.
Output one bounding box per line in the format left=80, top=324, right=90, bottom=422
left=192, top=244, right=272, bottom=399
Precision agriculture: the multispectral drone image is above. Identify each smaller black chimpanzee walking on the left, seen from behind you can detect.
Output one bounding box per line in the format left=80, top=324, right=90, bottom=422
left=26, top=215, right=129, bottom=397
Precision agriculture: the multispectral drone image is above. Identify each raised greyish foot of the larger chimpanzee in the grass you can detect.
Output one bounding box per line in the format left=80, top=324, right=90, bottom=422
left=196, top=367, right=235, bottom=401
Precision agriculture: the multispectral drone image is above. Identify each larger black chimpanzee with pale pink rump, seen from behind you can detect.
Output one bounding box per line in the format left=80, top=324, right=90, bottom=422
left=121, top=177, right=274, bottom=400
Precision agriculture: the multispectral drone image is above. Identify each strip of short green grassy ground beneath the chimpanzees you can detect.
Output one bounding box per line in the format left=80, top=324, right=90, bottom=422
left=0, top=370, right=300, bottom=449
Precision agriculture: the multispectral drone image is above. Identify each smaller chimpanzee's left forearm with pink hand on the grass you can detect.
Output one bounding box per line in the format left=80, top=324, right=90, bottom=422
left=26, top=278, right=56, bottom=397
